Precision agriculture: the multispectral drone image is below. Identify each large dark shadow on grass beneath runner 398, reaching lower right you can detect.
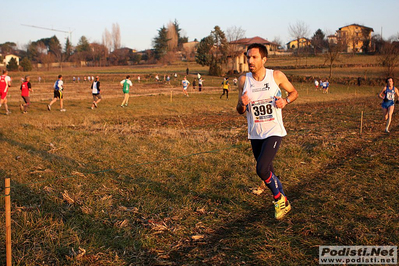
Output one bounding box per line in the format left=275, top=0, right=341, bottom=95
left=170, top=104, right=399, bottom=265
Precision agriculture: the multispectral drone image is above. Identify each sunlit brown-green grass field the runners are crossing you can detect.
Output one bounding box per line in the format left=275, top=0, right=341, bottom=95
left=0, top=63, right=399, bottom=265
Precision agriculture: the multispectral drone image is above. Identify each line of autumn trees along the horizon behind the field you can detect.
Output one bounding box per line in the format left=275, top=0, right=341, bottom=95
left=0, top=19, right=399, bottom=76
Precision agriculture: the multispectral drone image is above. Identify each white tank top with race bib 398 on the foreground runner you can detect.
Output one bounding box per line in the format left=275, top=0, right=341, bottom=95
left=243, top=69, right=287, bottom=139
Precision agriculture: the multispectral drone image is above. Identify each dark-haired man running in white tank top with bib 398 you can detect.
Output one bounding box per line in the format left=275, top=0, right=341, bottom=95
left=236, top=43, right=298, bottom=219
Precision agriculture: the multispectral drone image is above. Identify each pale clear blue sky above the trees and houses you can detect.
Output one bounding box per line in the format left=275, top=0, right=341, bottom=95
left=0, top=0, right=399, bottom=50
